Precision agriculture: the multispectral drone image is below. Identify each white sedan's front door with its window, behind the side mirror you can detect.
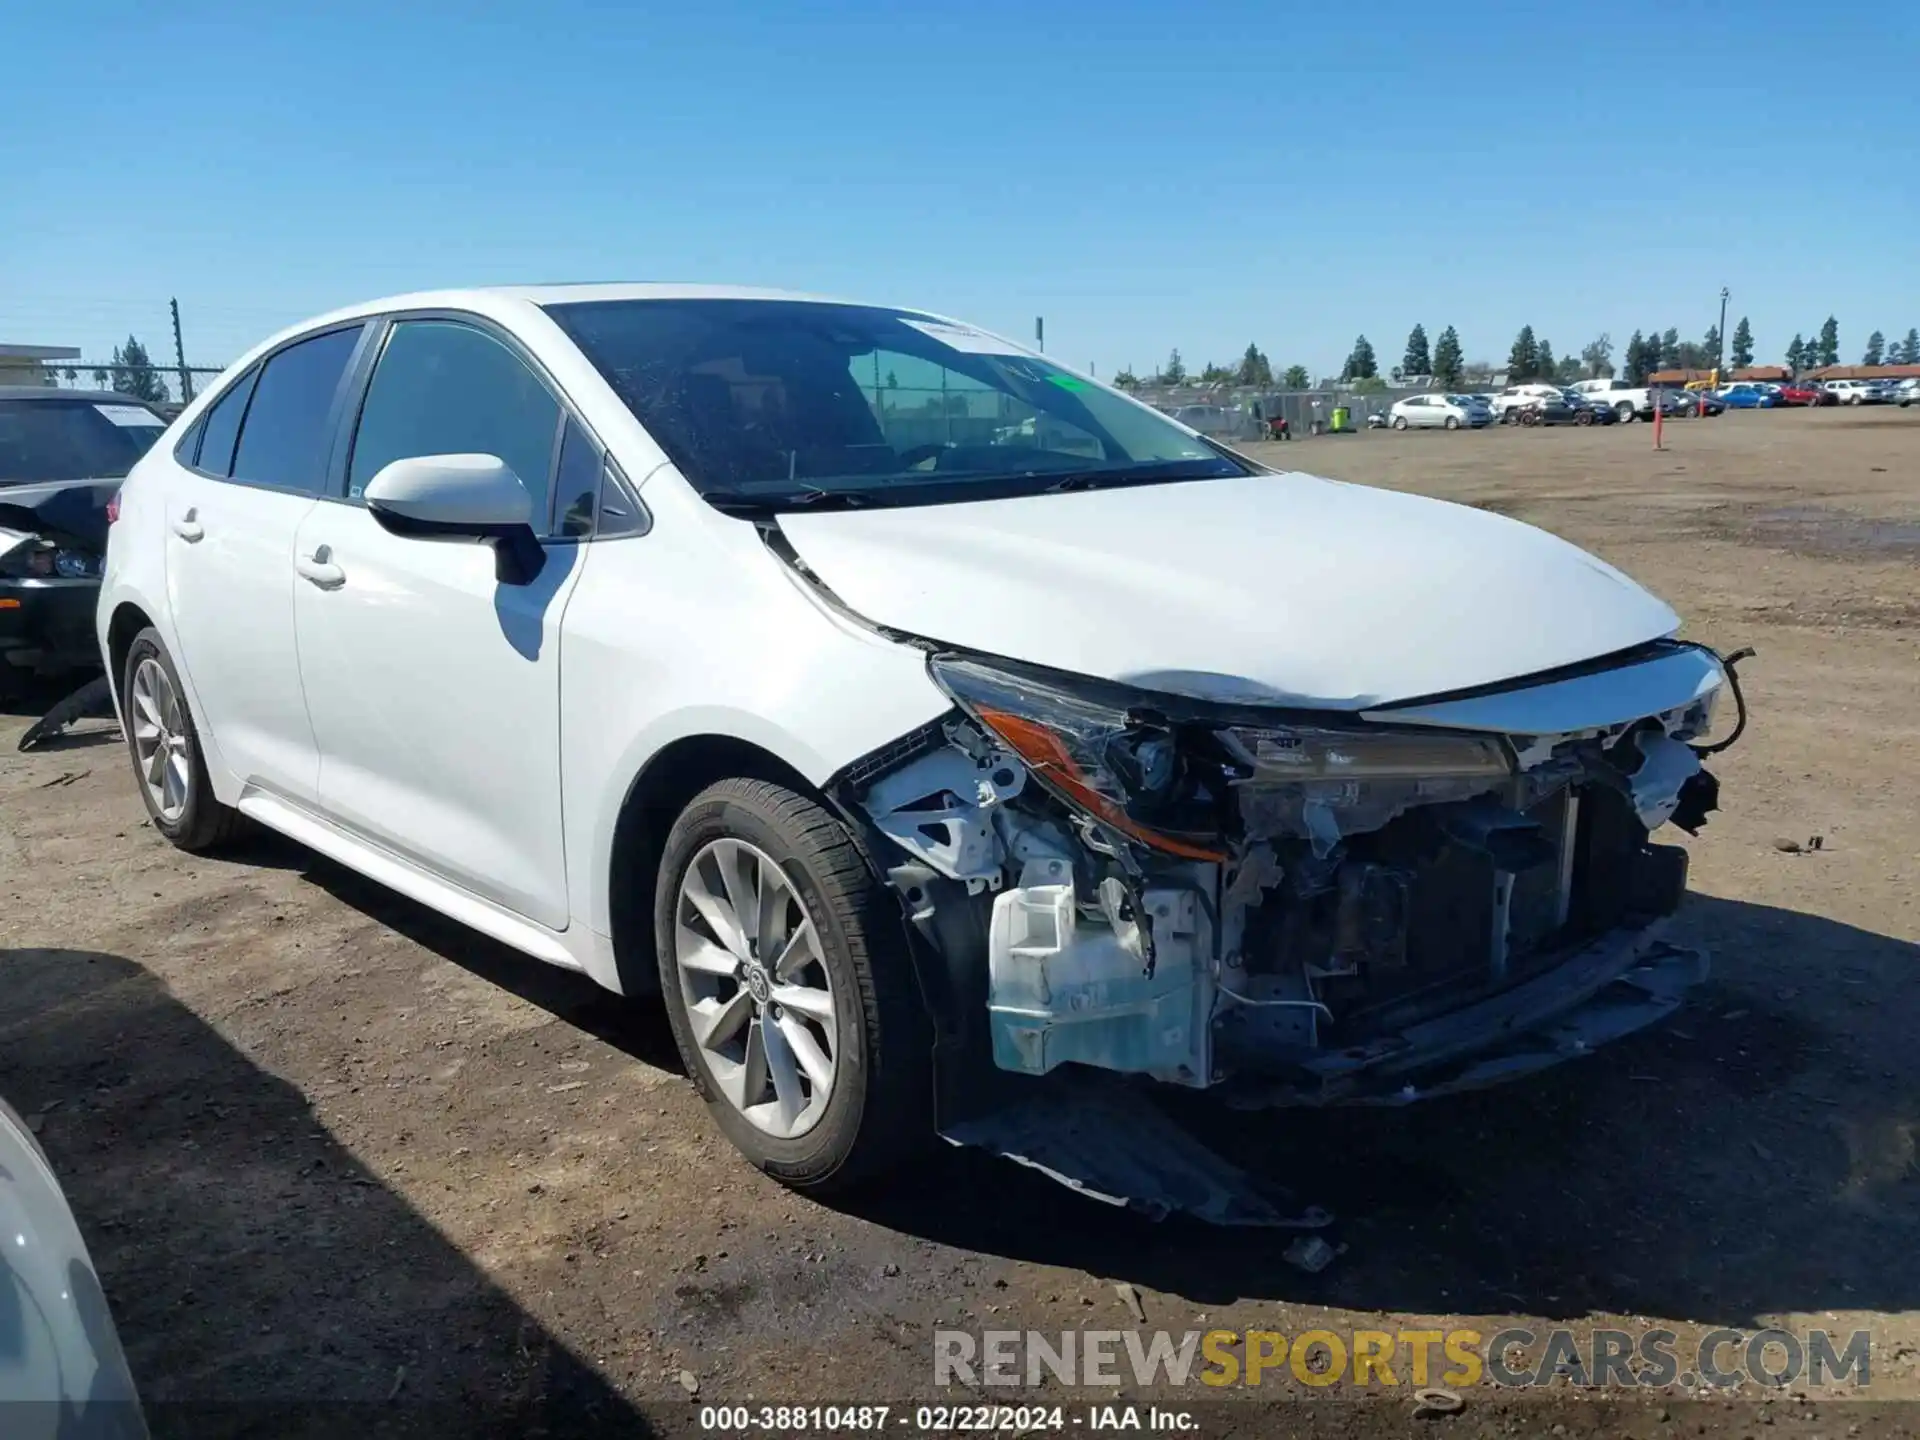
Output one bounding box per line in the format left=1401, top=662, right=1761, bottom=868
left=294, top=317, right=579, bottom=929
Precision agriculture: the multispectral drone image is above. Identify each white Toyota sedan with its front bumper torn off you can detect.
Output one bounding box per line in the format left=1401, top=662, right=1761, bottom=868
left=98, top=284, right=1738, bottom=1187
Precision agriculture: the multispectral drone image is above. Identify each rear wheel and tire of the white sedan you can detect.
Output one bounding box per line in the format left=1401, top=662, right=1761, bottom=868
left=121, top=626, right=240, bottom=854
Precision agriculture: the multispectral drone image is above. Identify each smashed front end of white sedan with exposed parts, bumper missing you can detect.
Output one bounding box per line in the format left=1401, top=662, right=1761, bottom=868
left=839, top=641, right=1738, bottom=1121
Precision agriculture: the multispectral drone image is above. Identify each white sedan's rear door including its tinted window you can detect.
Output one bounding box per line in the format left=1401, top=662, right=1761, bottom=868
left=165, top=324, right=363, bottom=803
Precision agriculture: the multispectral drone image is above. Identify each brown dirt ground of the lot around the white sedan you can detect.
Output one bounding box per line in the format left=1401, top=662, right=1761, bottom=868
left=11, top=411, right=1920, bottom=1436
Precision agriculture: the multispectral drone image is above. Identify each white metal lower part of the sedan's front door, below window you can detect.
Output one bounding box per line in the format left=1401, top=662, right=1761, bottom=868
left=288, top=503, right=593, bottom=929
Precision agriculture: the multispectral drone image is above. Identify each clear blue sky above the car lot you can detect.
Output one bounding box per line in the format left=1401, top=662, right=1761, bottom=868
left=0, top=0, right=1920, bottom=376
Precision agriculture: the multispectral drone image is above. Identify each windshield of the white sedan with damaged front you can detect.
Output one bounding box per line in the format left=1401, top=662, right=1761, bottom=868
left=547, top=300, right=1248, bottom=511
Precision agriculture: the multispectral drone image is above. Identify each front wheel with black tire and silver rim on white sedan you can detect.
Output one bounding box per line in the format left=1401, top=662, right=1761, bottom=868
left=653, top=780, right=933, bottom=1192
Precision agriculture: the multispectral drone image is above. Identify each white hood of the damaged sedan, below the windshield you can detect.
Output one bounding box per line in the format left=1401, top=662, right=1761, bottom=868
left=780, top=470, right=1680, bottom=710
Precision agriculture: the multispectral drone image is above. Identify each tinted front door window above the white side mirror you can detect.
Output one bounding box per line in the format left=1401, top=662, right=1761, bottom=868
left=348, top=321, right=561, bottom=526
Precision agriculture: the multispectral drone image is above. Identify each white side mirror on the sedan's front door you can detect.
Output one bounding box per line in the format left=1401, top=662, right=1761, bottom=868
left=365, top=455, right=547, bottom=586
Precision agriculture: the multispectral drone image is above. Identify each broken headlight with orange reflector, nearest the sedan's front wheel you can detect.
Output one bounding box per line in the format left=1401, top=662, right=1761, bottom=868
left=927, top=655, right=1227, bottom=860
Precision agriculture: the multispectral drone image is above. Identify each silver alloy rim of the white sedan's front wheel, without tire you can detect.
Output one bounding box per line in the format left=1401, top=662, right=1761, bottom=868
left=674, top=839, right=839, bottom=1140
